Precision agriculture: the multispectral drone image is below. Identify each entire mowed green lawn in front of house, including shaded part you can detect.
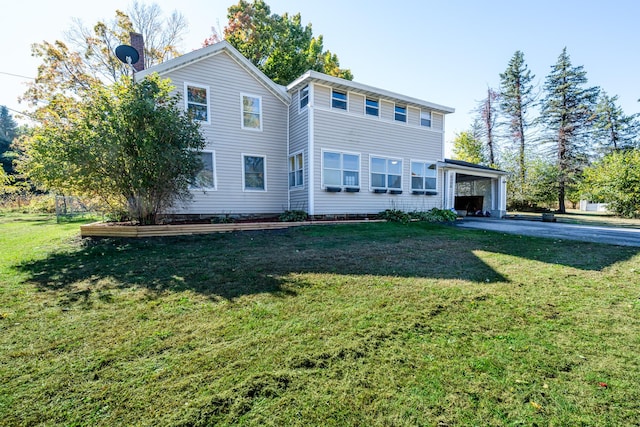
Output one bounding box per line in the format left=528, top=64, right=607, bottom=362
left=0, top=216, right=640, bottom=426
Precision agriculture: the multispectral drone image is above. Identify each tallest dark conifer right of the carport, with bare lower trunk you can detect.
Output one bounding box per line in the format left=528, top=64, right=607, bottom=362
left=540, top=48, right=599, bottom=213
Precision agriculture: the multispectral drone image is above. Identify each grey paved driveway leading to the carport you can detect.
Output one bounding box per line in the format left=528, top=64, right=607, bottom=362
left=456, top=217, right=640, bottom=247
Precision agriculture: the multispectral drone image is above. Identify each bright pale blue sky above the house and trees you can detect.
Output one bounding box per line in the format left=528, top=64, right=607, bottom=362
left=0, top=0, right=640, bottom=152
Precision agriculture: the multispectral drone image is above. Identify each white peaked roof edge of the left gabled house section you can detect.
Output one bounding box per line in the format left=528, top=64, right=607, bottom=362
left=136, top=40, right=291, bottom=105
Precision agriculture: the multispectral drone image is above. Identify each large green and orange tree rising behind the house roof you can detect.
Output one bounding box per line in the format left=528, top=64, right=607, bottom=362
left=222, top=0, right=353, bottom=85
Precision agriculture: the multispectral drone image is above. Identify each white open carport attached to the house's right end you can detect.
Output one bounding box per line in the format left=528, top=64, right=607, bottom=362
left=438, top=159, right=507, bottom=218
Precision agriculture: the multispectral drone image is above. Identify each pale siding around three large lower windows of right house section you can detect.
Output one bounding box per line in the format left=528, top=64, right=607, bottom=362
left=313, top=107, right=443, bottom=215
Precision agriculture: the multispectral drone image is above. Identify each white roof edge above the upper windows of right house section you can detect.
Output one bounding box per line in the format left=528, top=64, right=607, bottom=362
left=287, top=70, right=455, bottom=114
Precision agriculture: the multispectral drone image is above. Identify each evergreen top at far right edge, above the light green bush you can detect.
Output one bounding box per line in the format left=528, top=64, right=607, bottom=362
left=594, top=91, right=640, bottom=153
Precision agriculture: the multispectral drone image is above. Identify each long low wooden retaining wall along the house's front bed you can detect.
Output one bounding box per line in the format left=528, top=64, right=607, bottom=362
left=80, top=220, right=384, bottom=237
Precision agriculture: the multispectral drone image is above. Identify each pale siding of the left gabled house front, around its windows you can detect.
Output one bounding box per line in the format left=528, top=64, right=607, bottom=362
left=163, top=52, right=288, bottom=214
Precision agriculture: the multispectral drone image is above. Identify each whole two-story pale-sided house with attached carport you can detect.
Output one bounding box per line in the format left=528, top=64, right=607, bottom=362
left=137, top=42, right=506, bottom=216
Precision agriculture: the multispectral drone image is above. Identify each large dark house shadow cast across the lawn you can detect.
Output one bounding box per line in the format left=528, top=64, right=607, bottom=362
left=17, top=224, right=636, bottom=300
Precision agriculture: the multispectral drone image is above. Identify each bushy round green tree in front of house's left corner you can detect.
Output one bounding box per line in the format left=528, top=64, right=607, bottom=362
left=20, top=75, right=204, bottom=224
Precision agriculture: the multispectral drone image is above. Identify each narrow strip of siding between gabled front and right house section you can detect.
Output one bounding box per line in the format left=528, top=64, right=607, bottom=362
left=287, top=92, right=309, bottom=211
